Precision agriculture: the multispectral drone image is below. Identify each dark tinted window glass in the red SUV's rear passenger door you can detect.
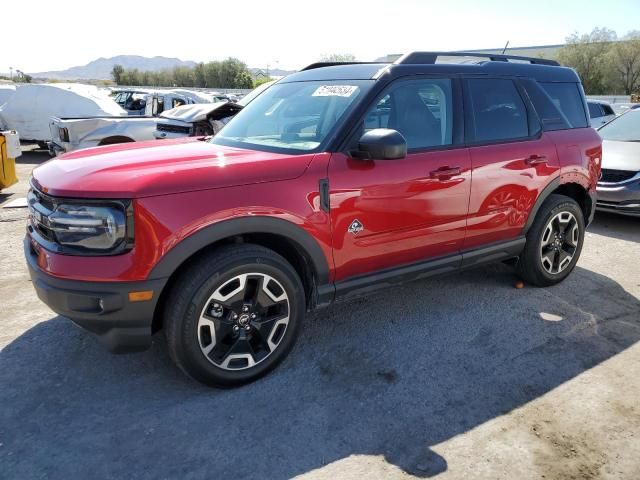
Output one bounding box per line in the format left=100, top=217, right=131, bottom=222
left=467, top=79, right=529, bottom=142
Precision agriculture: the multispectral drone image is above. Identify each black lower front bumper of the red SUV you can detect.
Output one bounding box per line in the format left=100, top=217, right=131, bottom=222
left=24, top=235, right=167, bottom=353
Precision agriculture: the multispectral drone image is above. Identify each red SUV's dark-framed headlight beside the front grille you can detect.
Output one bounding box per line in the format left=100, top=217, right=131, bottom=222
left=48, top=203, right=127, bottom=250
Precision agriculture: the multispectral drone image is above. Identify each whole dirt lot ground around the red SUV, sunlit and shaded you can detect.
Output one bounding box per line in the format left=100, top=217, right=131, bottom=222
left=0, top=148, right=640, bottom=480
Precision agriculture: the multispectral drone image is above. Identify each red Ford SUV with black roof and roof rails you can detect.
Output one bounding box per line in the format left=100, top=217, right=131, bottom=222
left=25, top=52, right=601, bottom=386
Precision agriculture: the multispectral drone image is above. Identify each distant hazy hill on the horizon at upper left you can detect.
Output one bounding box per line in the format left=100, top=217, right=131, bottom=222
left=30, top=55, right=196, bottom=80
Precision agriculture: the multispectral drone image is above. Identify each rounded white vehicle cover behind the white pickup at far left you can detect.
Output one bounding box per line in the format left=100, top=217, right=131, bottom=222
left=0, top=83, right=127, bottom=142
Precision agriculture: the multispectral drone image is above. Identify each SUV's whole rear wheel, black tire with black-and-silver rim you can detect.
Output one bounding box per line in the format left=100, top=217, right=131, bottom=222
left=518, top=194, right=585, bottom=287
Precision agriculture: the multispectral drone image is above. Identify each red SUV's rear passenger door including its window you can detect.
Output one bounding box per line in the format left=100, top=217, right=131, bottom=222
left=463, top=78, right=560, bottom=250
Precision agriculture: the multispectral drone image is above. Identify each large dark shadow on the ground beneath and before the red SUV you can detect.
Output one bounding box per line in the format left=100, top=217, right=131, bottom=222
left=0, top=265, right=640, bottom=479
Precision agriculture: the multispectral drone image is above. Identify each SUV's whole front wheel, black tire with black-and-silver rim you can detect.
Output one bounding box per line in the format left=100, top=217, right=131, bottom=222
left=163, top=244, right=305, bottom=387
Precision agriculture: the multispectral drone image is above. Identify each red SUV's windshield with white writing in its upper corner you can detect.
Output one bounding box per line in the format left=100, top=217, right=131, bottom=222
left=211, top=80, right=373, bottom=153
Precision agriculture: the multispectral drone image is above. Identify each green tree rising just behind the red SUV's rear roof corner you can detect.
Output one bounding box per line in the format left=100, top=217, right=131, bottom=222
left=558, top=27, right=616, bottom=95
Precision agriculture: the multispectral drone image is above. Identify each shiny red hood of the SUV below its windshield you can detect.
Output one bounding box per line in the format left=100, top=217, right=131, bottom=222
left=33, top=137, right=313, bottom=199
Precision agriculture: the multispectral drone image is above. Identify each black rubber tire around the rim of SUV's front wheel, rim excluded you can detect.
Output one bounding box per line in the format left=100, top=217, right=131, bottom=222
left=165, top=251, right=305, bottom=387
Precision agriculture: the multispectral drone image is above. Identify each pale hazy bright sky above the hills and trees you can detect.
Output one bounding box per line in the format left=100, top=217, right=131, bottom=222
left=5, top=0, right=640, bottom=72
